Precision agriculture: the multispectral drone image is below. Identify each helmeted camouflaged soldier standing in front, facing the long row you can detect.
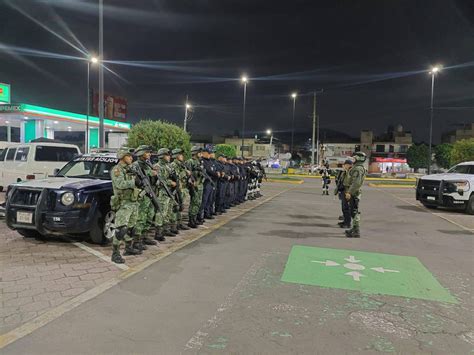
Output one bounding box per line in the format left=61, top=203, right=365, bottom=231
left=345, top=152, right=367, bottom=238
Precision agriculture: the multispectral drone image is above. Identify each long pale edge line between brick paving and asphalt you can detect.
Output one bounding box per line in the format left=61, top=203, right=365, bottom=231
left=0, top=188, right=293, bottom=350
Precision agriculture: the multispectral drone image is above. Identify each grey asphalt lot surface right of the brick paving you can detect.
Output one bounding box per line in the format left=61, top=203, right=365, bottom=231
left=2, top=180, right=474, bottom=354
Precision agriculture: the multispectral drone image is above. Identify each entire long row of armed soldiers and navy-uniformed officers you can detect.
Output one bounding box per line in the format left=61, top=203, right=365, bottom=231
left=111, top=145, right=265, bottom=263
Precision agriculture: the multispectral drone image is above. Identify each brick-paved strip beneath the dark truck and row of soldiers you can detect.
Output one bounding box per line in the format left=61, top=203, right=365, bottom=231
left=0, top=184, right=288, bottom=340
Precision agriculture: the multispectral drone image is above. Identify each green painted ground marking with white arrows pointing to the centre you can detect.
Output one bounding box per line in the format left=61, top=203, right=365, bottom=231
left=281, top=245, right=458, bottom=303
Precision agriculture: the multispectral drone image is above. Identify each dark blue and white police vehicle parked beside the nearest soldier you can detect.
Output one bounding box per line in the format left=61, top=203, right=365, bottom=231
left=5, top=153, right=118, bottom=243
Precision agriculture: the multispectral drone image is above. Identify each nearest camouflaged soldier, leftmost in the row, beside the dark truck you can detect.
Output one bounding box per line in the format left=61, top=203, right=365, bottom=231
left=110, top=147, right=141, bottom=264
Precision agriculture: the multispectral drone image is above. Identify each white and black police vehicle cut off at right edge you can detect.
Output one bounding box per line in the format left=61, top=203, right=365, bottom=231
left=416, top=161, right=474, bottom=214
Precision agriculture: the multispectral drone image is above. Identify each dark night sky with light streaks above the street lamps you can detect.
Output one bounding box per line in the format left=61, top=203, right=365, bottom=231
left=0, top=0, right=474, bottom=142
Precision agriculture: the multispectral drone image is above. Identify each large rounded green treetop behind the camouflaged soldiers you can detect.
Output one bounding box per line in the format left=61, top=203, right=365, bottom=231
left=128, top=120, right=191, bottom=156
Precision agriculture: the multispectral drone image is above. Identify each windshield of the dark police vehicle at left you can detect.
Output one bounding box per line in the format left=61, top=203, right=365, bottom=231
left=56, top=157, right=117, bottom=180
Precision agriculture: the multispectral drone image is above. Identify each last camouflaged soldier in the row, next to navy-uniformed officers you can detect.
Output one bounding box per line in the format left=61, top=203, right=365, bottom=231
left=186, top=146, right=203, bottom=228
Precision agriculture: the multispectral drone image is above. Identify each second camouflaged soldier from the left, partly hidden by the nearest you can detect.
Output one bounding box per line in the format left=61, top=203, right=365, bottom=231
left=133, top=145, right=157, bottom=250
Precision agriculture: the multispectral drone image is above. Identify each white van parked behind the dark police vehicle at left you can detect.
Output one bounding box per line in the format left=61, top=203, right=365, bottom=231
left=0, top=143, right=80, bottom=191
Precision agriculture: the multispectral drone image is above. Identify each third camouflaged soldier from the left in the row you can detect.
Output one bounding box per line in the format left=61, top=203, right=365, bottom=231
left=153, top=148, right=176, bottom=241
